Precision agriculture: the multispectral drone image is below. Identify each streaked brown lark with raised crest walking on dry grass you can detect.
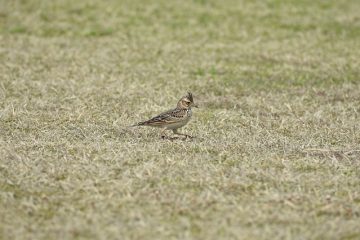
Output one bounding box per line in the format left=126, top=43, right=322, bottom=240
left=132, top=92, right=198, bottom=139
